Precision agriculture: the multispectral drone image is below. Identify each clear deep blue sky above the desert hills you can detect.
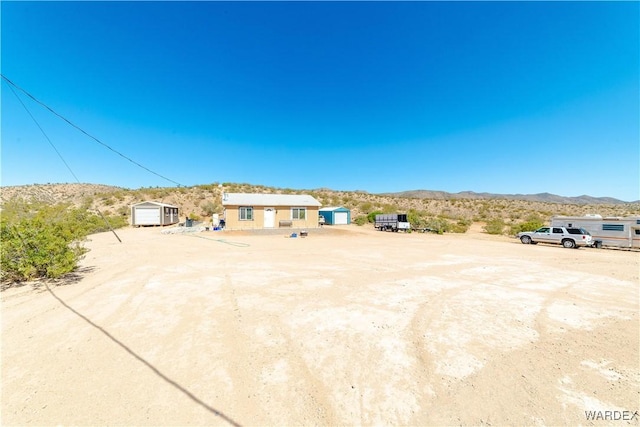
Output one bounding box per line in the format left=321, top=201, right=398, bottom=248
left=0, top=1, right=640, bottom=201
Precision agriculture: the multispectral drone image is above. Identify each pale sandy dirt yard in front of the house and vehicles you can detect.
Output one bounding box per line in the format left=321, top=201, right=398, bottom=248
left=1, top=226, right=640, bottom=426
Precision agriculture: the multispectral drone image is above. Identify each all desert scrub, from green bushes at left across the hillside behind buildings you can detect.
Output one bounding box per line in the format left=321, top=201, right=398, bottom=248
left=0, top=182, right=640, bottom=281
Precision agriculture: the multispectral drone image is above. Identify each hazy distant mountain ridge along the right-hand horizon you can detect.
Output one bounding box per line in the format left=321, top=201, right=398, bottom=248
left=380, top=190, right=640, bottom=205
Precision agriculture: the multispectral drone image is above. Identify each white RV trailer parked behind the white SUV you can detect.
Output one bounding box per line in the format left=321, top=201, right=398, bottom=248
left=551, top=215, right=640, bottom=249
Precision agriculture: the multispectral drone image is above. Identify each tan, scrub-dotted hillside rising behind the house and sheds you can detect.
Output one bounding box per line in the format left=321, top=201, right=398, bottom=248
left=0, top=183, right=640, bottom=229
